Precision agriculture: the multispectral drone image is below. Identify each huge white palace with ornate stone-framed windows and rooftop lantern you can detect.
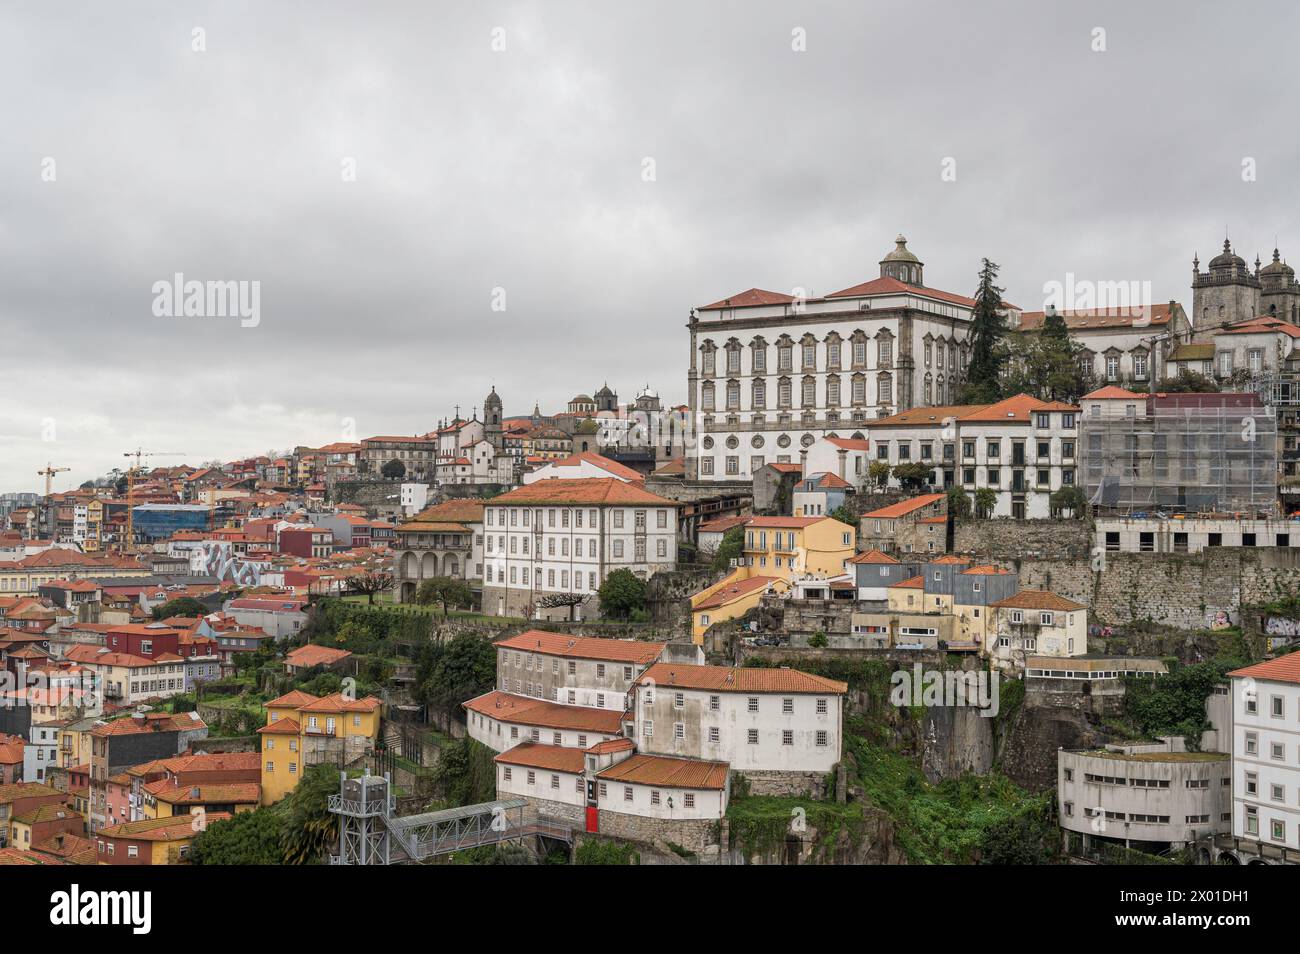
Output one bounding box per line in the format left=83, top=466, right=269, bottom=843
left=686, top=235, right=975, bottom=481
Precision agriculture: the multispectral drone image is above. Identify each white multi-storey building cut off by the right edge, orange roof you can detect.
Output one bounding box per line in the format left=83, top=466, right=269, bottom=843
left=1230, top=654, right=1300, bottom=850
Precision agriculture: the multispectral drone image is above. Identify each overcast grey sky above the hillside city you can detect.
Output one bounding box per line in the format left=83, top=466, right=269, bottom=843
left=0, top=0, right=1300, bottom=490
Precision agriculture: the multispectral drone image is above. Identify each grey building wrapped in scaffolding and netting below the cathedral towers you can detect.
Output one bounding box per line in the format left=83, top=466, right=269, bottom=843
left=1083, top=394, right=1278, bottom=516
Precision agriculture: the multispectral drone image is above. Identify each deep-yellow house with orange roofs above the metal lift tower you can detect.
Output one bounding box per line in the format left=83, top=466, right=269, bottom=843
left=257, top=689, right=384, bottom=805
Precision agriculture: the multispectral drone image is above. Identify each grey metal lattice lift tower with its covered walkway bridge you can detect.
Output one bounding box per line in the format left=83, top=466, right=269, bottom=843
left=329, top=775, right=573, bottom=864
